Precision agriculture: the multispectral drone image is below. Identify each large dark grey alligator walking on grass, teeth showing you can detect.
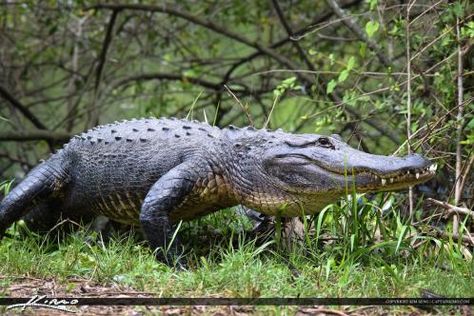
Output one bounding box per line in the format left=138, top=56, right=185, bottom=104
left=0, top=118, right=436, bottom=263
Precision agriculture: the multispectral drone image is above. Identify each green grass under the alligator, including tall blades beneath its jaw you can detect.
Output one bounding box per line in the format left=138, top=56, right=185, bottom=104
left=0, top=180, right=474, bottom=314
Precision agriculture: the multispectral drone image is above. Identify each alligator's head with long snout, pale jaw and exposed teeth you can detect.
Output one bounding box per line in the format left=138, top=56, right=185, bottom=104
left=235, top=132, right=436, bottom=215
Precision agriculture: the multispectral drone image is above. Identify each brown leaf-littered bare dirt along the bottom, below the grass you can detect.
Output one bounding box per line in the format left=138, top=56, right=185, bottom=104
left=0, top=276, right=472, bottom=316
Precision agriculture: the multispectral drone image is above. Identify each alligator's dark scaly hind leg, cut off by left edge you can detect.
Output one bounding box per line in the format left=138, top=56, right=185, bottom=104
left=0, top=156, right=66, bottom=238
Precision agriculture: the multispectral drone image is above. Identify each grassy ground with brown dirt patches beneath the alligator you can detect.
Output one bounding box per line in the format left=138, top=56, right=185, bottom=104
left=0, top=201, right=474, bottom=315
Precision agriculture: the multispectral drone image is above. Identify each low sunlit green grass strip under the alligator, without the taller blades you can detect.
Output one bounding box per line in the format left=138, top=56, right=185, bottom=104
left=0, top=215, right=474, bottom=297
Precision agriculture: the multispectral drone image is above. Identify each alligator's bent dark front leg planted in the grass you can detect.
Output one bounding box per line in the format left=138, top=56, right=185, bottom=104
left=140, top=163, right=199, bottom=265
